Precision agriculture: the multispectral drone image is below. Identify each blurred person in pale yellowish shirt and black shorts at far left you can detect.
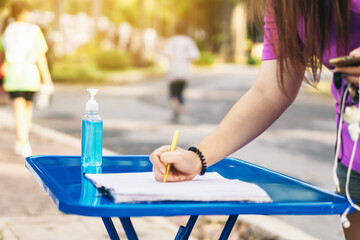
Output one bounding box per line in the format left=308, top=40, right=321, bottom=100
left=2, top=1, right=54, bottom=157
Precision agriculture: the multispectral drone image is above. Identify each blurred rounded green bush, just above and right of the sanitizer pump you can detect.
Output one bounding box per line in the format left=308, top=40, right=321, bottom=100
left=96, top=50, right=131, bottom=70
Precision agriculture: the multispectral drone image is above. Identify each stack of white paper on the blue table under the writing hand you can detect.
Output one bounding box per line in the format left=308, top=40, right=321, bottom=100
left=85, top=172, right=271, bottom=203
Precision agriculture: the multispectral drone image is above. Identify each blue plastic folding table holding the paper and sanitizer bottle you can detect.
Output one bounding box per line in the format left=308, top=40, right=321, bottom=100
left=25, top=156, right=350, bottom=239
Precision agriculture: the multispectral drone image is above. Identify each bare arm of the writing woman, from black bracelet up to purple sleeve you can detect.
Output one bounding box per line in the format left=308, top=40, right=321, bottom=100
left=198, top=59, right=302, bottom=165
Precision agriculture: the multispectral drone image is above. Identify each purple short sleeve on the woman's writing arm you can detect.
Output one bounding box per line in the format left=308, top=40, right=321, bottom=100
left=261, top=13, right=278, bottom=61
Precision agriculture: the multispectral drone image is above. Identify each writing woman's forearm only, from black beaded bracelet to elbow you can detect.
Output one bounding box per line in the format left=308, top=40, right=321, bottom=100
left=198, top=89, right=288, bottom=165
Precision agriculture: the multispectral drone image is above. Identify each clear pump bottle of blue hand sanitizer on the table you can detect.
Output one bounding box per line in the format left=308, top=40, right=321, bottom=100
left=81, top=89, right=103, bottom=167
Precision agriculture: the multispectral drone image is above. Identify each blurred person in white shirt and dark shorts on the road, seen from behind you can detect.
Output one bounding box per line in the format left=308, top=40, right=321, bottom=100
left=164, top=22, right=200, bottom=122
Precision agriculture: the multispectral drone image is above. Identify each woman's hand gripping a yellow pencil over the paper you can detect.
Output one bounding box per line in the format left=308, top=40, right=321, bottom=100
left=150, top=146, right=201, bottom=182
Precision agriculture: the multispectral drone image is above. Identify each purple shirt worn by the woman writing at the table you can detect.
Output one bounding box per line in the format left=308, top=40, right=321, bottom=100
left=262, top=0, right=360, bottom=172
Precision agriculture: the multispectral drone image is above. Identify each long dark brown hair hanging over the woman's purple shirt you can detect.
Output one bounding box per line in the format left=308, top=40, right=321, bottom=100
left=248, top=0, right=350, bottom=90
